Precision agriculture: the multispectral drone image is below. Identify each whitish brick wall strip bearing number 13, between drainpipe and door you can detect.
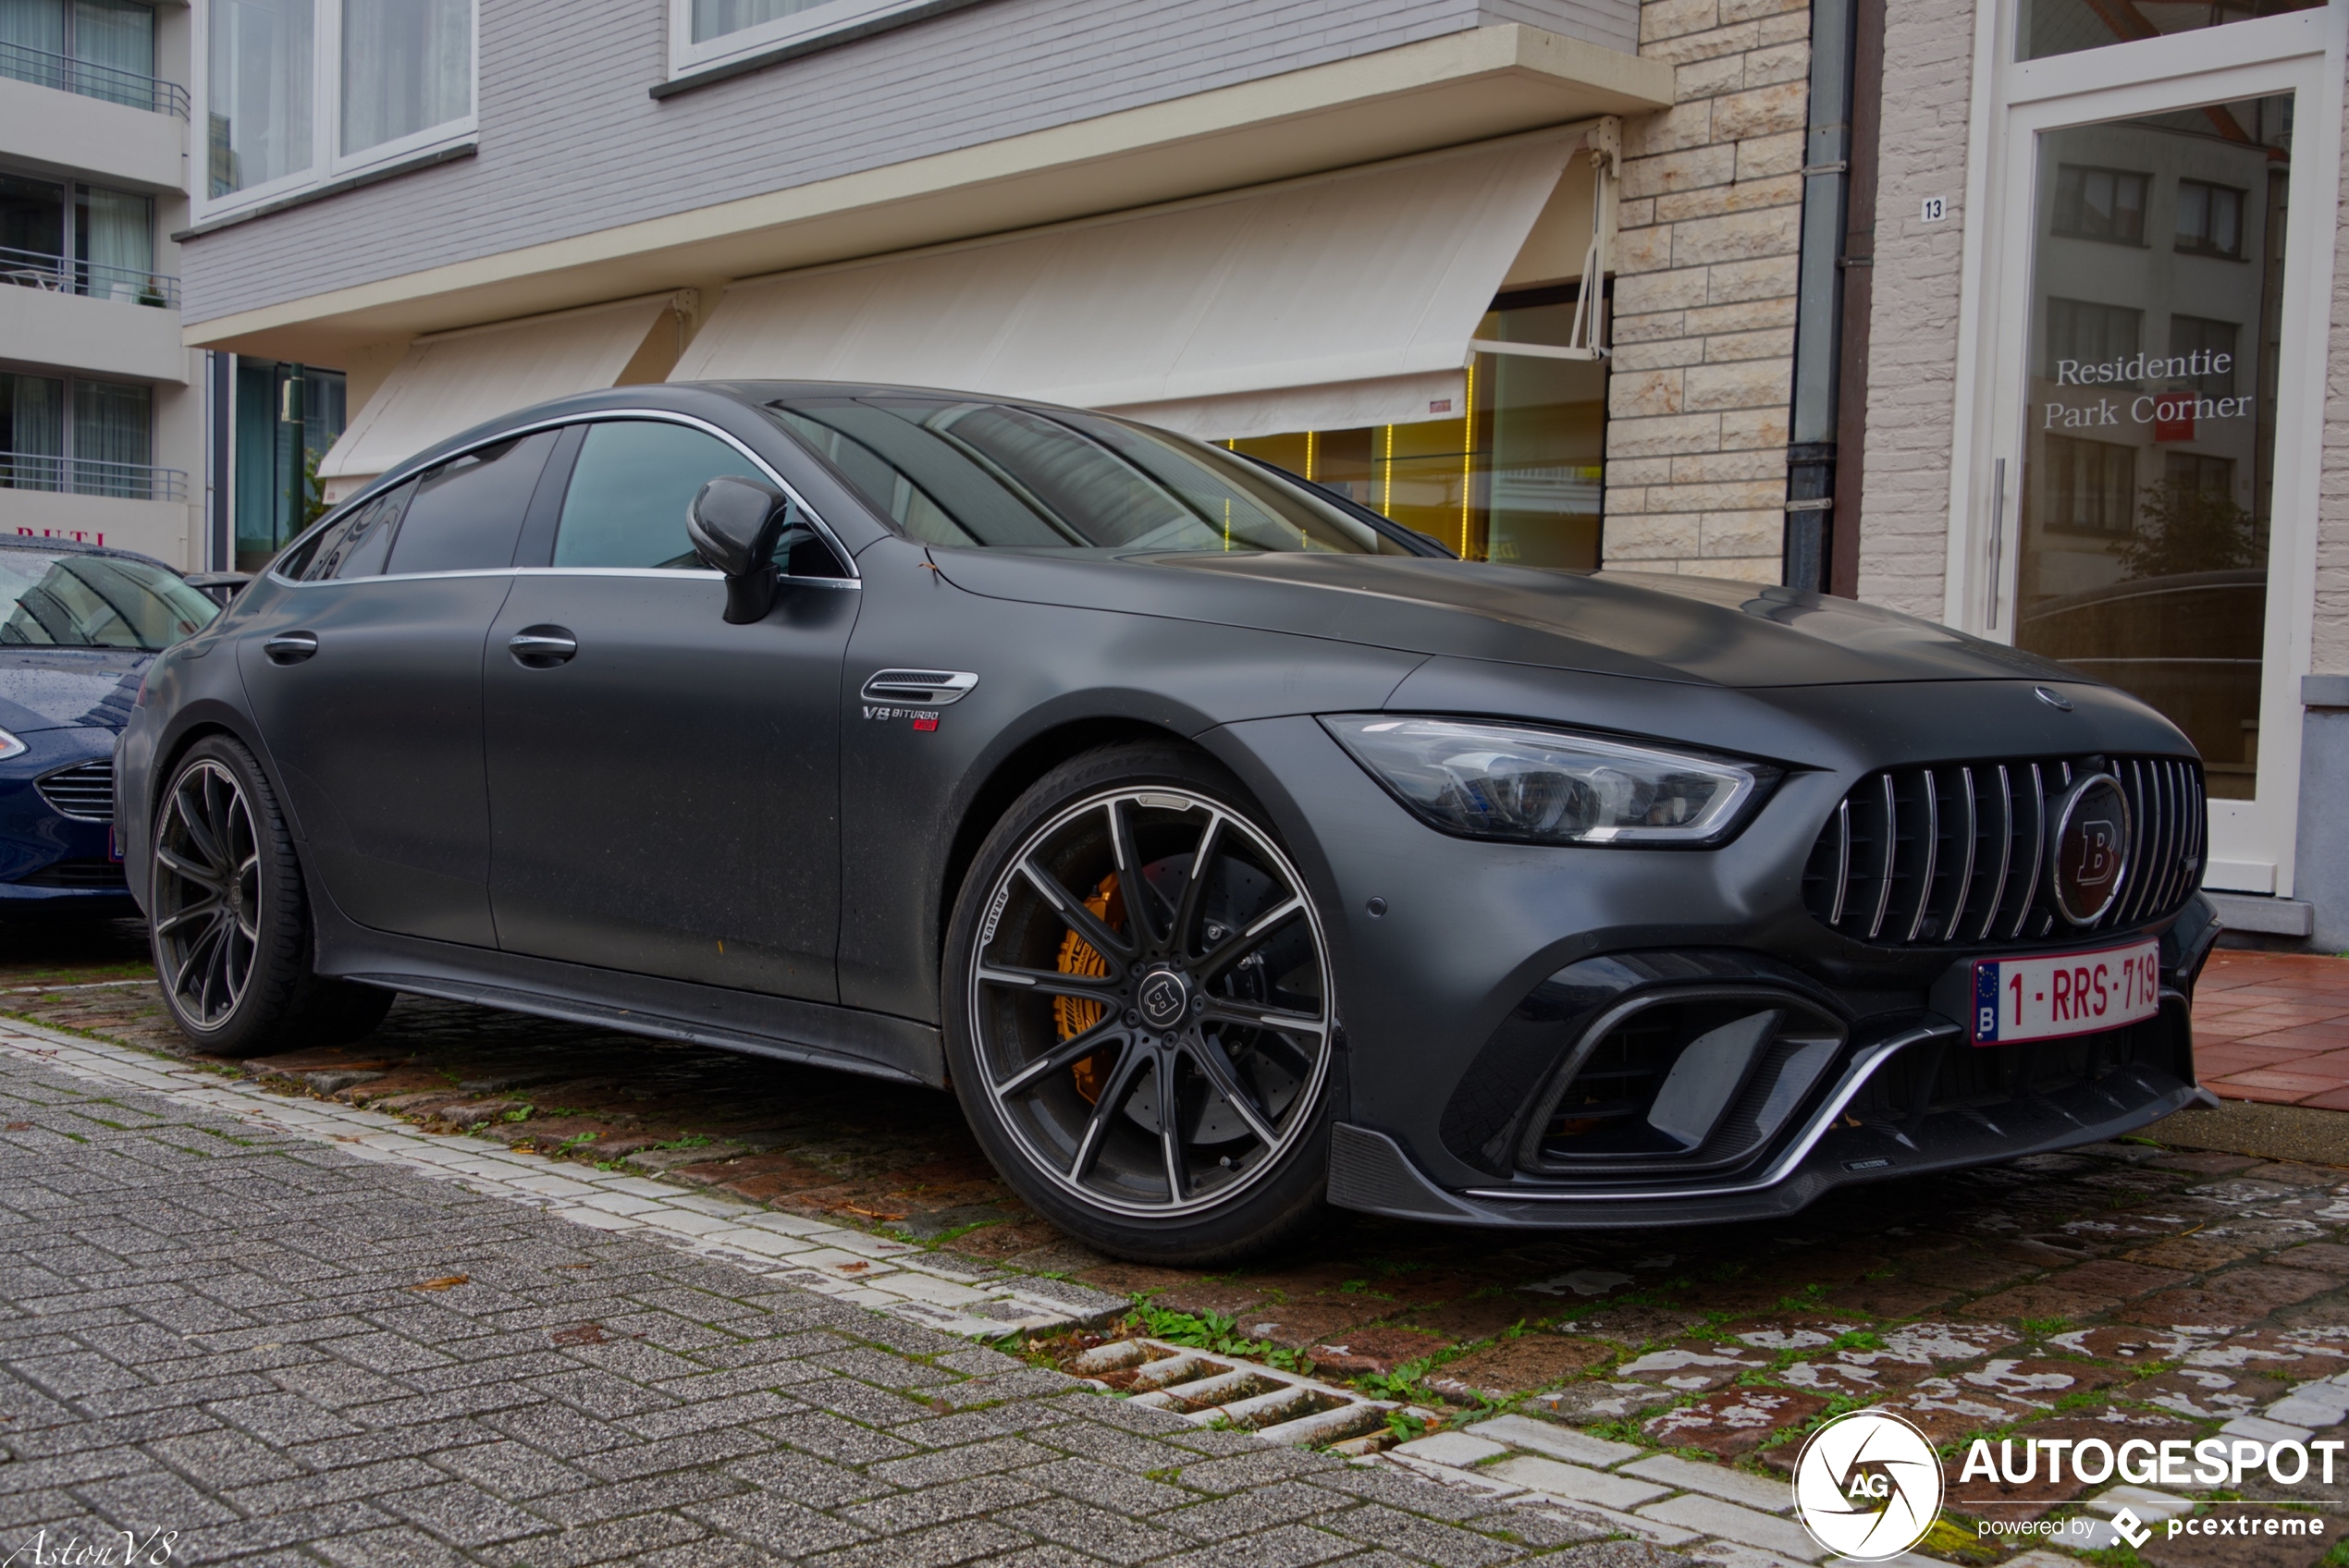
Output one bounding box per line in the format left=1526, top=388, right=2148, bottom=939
left=1861, top=0, right=1974, bottom=619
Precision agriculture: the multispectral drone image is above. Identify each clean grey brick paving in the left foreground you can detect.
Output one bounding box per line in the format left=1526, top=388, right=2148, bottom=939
left=0, top=1054, right=1654, bottom=1568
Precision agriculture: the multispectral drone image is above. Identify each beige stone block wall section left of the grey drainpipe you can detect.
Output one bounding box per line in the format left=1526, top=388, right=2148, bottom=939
left=1605, top=0, right=1813, bottom=582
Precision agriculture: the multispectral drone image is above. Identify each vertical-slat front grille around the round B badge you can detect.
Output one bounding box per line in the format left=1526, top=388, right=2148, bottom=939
left=1802, top=756, right=2206, bottom=949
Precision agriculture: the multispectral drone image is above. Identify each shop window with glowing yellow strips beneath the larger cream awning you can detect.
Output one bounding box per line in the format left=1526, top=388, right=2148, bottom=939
left=1226, top=287, right=1606, bottom=570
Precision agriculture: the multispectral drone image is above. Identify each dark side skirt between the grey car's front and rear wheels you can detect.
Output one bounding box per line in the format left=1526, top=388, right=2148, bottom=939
left=313, top=920, right=947, bottom=1089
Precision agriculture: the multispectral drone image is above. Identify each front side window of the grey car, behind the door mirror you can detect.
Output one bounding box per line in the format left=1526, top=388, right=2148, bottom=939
left=554, top=420, right=758, bottom=570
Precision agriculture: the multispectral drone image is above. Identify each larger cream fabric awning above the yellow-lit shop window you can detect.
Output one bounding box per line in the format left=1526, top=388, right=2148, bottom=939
left=671, top=127, right=1586, bottom=439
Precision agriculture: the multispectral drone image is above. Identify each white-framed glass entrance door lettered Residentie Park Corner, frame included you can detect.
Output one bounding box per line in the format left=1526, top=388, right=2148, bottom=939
left=1949, top=0, right=2349, bottom=894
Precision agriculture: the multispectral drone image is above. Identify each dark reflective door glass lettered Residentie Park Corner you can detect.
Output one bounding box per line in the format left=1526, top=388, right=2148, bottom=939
left=2015, top=92, right=2293, bottom=801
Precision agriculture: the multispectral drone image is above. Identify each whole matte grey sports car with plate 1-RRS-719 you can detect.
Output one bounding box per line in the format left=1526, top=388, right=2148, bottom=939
left=117, top=383, right=2215, bottom=1260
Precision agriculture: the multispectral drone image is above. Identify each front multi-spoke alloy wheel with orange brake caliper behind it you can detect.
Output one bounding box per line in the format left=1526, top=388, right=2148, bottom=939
left=958, top=781, right=1336, bottom=1223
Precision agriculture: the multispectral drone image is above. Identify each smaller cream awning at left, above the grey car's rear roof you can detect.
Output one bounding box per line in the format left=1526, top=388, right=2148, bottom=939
left=317, top=293, right=679, bottom=479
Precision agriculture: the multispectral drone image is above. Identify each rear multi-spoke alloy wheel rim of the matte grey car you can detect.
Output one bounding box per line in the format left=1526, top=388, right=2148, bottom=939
left=153, top=761, right=261, bottom=1028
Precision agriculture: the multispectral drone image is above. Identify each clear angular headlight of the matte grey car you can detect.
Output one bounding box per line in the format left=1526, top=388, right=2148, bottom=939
left=1322, top=714, right=1776, bottom=845
